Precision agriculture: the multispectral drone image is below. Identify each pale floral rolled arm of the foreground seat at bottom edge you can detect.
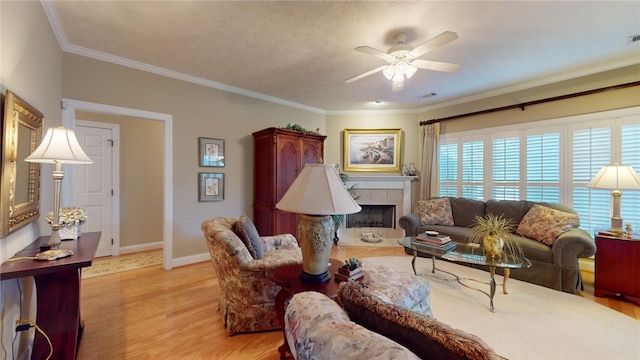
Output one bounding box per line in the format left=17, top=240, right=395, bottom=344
left=285, top=291, right=419, bottom=360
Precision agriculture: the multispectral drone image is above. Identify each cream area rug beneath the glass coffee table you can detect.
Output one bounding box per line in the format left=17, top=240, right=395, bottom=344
left=362, top=256, right=640, bottom=360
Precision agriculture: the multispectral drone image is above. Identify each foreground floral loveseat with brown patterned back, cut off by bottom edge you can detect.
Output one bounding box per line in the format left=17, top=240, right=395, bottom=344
left=285, top=265, right=499, bottom=360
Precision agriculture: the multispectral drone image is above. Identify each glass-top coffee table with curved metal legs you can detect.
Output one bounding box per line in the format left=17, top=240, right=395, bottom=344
left=398, top=236, right=531, bottom=311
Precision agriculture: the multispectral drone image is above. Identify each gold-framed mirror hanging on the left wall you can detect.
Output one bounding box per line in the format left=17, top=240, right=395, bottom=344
left=0, top=90, right=44, bottom=238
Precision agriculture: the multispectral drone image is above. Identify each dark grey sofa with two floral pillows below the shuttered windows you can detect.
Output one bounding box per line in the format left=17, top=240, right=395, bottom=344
left=398, top=198, right=596, bottom=293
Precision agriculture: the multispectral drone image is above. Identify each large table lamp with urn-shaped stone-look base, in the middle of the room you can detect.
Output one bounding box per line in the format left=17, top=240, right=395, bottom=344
left=276, top=164, right=362, bottom=283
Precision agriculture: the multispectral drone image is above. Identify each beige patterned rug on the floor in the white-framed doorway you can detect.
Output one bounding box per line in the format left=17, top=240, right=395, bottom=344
left=82, top=250, right=162, bottom=279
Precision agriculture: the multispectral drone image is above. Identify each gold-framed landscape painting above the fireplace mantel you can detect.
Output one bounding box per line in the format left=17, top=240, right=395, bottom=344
left=343, top=129, right=402, bottom=172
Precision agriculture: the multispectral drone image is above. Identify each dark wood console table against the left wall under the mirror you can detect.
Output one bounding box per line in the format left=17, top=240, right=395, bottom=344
left=0, top=232, right=101, bottom=360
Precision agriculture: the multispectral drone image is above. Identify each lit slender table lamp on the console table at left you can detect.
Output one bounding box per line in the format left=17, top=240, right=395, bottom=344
left=25, top=126, right=93, bottom=260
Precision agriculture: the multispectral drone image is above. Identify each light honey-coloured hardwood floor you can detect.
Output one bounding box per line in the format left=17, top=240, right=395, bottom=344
left=78, top=246, right=640, bottom=360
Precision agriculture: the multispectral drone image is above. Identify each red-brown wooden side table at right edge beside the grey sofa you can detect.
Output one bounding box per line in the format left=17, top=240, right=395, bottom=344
left=595, top=233, right=640, bottom=303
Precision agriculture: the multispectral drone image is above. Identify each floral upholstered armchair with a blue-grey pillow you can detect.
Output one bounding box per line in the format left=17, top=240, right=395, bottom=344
left=202, top=215, right=302, bottom=335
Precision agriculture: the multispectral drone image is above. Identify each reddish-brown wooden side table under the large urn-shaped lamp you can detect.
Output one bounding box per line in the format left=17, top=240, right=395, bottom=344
left=273, top=259, right=370, bottom=359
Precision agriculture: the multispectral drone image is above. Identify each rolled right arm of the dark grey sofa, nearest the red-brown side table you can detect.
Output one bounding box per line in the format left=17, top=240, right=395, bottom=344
left=551, top=228, right=596, bottom=265
